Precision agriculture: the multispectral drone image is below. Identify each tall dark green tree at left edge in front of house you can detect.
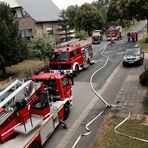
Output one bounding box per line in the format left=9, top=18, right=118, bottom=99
left=0, top=2, right=27, bottom=75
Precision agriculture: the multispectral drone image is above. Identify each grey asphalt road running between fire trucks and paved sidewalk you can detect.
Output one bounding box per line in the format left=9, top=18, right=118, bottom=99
left=44, top=22, right=145, bottom=148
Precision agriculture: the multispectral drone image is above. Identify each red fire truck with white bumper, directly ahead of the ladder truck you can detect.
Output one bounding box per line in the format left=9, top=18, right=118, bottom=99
left=49, top=41, right=93, bottom=76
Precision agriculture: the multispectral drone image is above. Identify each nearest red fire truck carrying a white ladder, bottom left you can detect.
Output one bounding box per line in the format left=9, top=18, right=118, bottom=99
left=0, top=73, right=72, bottom=148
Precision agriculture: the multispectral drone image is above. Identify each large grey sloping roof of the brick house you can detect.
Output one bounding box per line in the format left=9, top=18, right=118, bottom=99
left=4, top=0, right=60, bottom=22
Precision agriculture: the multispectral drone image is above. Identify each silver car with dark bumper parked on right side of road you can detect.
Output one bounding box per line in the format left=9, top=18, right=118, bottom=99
left=123, top=45, right=144, bottom=67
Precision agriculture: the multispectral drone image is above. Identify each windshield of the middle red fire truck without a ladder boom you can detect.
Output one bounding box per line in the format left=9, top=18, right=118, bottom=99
left=50, top=52, right=68, bottom=62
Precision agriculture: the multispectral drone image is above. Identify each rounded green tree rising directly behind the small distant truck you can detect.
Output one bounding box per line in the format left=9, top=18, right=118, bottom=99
left=76, top=3, right=104, bottom=35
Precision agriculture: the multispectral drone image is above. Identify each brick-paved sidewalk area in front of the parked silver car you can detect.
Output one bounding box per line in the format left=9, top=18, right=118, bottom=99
left=102, top=53, right=148, bottom=114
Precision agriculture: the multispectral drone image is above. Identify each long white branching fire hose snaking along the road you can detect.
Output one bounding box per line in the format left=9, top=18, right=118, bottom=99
left=72, top=33, right=148, bottom=148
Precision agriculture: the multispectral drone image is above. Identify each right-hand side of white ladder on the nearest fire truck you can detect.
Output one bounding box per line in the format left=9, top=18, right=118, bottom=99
left=0, top=80, right=41, bottom=125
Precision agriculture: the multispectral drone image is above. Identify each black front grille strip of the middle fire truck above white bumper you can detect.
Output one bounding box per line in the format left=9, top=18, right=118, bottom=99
left=50, top=64, right=71, bottom=70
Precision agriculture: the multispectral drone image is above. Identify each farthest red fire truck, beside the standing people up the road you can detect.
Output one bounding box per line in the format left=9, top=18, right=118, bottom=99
left=106, top=26, right=122, bottom=41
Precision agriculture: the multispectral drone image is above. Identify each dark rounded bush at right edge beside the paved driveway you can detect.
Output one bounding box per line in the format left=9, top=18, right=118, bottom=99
left=139, top=70, right=148, bottom=86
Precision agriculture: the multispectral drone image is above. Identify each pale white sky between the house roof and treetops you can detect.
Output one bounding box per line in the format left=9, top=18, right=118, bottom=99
left=52, top=0, right=94, bottom=9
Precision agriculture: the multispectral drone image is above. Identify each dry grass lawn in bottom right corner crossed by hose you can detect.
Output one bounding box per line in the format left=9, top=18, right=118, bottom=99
left=93, top=116, right=148, bottom=148
